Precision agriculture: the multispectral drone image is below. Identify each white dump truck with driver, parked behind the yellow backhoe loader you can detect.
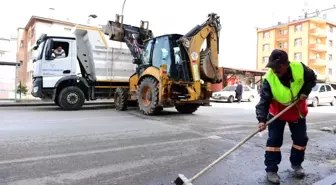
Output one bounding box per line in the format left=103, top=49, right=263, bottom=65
left=31, top=25, right=136, bottom=110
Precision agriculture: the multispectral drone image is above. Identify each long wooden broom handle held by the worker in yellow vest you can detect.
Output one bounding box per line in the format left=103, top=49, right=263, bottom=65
left=189, top=99, right=299, bottom=182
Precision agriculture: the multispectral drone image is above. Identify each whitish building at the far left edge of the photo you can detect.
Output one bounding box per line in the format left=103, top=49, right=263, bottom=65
left=0, top=35, right=17, bottom=99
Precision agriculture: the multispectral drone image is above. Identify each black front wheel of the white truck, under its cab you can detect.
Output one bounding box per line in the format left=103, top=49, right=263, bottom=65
left=58, top=86, right=85, bottom=110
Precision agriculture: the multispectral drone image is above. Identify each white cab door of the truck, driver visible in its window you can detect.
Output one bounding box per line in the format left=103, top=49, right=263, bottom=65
left=42, top=38, right=77, bottom=88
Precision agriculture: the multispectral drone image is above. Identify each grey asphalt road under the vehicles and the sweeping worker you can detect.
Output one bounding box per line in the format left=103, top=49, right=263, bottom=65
left=0, top=103, right=336, bottom=185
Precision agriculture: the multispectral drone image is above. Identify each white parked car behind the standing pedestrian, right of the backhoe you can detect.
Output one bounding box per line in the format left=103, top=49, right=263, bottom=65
left=212, top=85, right=258, bottom=103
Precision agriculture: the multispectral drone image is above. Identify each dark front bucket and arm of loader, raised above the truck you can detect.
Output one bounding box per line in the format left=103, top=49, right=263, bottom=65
left=103, top=15, right=153, bottom=59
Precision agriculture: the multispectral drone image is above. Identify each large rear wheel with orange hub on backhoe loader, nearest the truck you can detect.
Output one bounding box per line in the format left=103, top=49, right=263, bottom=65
left=138, top=77, right=162, bottom=115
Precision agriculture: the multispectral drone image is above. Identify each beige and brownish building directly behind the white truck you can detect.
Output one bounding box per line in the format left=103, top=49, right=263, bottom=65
left=17, top=16, right=75, bottom=95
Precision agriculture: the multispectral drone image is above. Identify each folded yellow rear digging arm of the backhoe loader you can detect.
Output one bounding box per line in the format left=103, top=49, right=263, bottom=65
left=179, top=13, right=222, bottom=83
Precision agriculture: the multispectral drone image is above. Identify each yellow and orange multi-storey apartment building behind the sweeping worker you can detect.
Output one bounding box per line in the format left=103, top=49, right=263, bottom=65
left=257, top=17, right=336, bottom=82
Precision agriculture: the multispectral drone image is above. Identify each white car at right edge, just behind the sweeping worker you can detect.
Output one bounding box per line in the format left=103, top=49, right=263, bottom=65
left=307, top=83, right=336, bottom=107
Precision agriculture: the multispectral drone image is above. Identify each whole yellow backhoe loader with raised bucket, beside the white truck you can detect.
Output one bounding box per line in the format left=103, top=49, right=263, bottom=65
left=105, top=14, right=221, bottom=115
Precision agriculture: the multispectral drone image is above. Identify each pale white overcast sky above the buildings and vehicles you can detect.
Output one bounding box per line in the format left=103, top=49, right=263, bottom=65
left=0, top=0, right=336, bottom=69
